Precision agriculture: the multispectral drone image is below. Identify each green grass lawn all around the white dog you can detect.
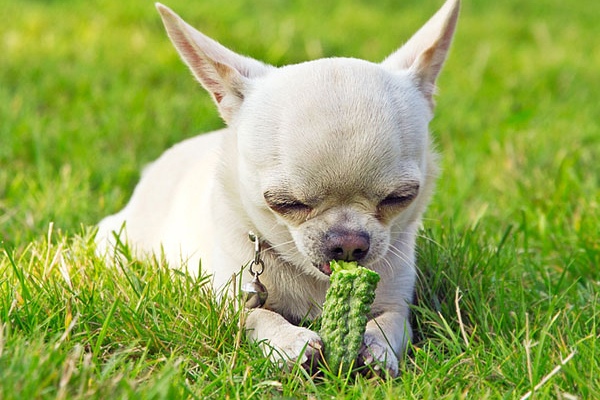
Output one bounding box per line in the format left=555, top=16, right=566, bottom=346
left=0, top=0, right=600, bottom=399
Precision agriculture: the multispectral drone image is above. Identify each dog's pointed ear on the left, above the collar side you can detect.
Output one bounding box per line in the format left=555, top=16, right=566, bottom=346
left=156, top=3, right=273, bottom=123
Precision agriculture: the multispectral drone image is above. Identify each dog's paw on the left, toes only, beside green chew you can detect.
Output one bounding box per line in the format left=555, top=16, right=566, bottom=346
left=265, top=326, right=323, bottom=369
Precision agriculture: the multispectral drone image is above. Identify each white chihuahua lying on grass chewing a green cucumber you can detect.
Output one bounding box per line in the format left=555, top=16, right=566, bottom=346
left=97, top=0, right=459, bottom=376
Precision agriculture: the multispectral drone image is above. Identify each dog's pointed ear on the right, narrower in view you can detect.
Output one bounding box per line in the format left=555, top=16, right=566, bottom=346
left=382, top=0, right=460, bottom=108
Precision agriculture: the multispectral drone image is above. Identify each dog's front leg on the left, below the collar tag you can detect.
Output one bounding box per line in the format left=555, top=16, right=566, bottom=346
left=246, top=308, right=323, bottom=367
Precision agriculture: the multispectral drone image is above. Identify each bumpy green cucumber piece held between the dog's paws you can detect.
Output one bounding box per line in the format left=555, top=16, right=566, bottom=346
left=319, top=261, right=379, bottom=374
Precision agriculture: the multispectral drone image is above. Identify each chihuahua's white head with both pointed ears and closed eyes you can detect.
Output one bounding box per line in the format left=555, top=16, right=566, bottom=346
left=157, top=0, right=459, bottom=279
